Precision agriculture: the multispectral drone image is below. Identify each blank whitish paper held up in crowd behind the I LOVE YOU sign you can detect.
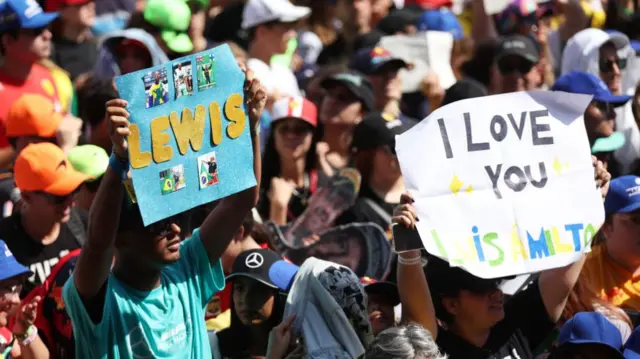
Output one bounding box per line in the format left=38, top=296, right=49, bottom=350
left=380, top=31, right=456, bottom=93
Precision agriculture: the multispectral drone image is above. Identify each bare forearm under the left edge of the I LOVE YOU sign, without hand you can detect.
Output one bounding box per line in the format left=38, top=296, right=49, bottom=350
left=397, top=251, right=438, bottom=340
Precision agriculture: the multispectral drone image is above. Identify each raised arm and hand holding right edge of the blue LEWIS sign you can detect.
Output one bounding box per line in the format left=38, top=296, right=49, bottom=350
left=200, top=64, right=267, bottom=262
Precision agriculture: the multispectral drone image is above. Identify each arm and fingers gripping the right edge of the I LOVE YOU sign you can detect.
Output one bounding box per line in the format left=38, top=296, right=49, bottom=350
left=539, top=157, right=611, bottom=322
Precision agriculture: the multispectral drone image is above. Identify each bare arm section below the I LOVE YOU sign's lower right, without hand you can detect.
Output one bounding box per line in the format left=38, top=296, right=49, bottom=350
left=538, top=255, right=586, bottom=322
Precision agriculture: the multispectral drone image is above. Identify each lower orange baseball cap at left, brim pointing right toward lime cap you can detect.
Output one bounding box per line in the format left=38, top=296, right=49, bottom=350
left=13, top=142, right=91, bottom=196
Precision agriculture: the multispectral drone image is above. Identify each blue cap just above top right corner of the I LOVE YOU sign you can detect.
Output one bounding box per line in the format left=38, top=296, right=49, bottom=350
left=551, top=71, right=631, bottom=106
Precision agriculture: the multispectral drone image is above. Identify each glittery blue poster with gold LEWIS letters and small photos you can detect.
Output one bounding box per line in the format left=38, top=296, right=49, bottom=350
left=116, top=45, right=256, bottom=226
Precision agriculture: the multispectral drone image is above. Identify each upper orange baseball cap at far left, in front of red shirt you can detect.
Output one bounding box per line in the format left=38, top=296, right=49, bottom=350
left=6, top=94, right=62, bottom=138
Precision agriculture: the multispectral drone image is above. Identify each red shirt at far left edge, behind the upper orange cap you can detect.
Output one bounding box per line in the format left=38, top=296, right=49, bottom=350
left=0, top=64, right=62, bottom=148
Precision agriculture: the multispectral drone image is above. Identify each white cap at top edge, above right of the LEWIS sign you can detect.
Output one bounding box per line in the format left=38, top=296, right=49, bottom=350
left=242, top=0, right=311, bottom=29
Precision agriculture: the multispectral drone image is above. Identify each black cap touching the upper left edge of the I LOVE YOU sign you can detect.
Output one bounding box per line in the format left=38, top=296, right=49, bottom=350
left=351, top=112, right=415, bottom=153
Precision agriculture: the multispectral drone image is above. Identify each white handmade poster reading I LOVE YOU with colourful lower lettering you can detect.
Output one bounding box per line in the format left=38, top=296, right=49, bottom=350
left=396, top=91, right=604, bottom=278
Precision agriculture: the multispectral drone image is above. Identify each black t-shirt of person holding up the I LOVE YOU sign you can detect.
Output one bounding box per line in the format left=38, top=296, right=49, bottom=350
left=436, top=281, right=555, bottom=359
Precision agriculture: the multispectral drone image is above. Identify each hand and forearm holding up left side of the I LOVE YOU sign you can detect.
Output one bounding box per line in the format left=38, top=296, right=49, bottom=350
left=393, top=194, right=438, bottom=340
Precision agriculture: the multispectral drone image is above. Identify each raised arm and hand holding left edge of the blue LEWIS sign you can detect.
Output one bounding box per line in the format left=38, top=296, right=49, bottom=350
left=73, top=99, right=129, bottom=300
